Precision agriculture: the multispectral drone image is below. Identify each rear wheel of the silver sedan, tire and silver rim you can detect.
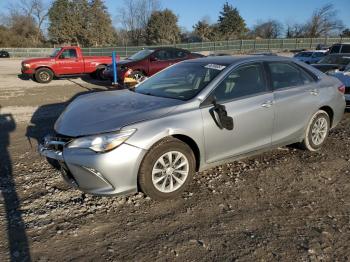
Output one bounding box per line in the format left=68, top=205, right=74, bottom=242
left=301, top=110, right=330, bottom=152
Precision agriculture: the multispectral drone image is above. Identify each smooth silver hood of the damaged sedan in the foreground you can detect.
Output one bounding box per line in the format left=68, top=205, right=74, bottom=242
left=55, top=90, right=182, bottom=137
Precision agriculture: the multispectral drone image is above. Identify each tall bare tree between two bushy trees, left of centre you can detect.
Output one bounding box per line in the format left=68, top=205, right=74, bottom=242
left=119, top=0, right=160, bottom=45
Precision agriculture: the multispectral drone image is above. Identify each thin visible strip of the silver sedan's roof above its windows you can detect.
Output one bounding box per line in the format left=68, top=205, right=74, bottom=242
left=183, top=55, right=293, bottom=66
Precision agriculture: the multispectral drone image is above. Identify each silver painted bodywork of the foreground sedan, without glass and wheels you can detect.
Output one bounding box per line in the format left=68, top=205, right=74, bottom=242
left=41, top=56, right=345, bottom=194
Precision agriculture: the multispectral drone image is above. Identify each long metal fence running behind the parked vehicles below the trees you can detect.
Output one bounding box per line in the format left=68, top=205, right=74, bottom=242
left=0, top=37, right=350, bottom=57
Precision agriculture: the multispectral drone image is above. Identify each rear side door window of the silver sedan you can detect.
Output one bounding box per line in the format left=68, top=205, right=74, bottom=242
left=268, top=62, right=314, bottom=90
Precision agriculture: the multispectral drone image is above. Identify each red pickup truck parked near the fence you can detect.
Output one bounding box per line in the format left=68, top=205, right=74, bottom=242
left=21, top=46, right=112, bottom=83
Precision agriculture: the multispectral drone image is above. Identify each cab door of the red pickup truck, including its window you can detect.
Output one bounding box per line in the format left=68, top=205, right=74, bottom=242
left=56, top=48, right=84, bottom=75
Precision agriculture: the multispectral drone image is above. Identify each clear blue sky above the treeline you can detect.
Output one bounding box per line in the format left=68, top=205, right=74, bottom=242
left=0, top=0, right=350, bottom=30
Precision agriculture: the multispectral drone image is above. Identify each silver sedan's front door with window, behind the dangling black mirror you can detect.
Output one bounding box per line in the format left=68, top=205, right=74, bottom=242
left=201, top=63, right=274, bottom=163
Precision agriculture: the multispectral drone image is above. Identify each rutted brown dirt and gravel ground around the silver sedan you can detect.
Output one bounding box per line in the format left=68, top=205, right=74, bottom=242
left=0, top=60, right=350, bottom=261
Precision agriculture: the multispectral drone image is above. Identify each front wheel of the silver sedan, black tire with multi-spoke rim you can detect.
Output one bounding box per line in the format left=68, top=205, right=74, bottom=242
left=138, top=138, right=196, bottom=201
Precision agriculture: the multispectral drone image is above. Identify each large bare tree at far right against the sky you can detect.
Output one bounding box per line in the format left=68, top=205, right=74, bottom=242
left=305, top=4, right=344, bottom=37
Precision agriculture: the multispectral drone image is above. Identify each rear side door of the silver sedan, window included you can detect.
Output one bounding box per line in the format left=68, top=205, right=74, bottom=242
left=266, top=61, right=319, bottom=145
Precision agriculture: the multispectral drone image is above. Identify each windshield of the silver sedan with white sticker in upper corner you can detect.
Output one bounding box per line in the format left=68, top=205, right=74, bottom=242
left=135, top=62, right=225, bottom=100
